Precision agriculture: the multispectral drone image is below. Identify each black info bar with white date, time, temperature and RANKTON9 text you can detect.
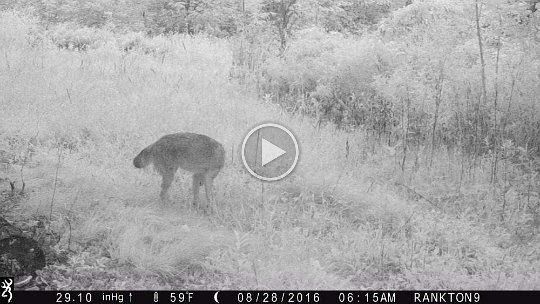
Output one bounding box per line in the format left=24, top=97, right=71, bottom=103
left=0, top=290, right=540, bottom=304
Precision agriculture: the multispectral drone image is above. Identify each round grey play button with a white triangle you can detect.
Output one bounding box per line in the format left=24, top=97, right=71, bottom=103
left=242, top=123, right=299, bottom=181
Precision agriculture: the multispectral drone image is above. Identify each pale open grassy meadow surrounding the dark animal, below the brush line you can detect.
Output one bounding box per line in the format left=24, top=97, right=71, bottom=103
left=0, top=12, right=540, bottom=289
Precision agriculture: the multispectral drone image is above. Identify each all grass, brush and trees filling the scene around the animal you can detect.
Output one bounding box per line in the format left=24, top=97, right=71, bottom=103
left=0, top=0, right=540, bottom=289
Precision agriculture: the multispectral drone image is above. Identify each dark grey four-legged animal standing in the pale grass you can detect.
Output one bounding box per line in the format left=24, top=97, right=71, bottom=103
left=133, top=133, right=225, bottom=205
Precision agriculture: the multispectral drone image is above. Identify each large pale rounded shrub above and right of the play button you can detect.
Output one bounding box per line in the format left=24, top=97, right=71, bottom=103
left=261, top=28, right=391, bottom=127
